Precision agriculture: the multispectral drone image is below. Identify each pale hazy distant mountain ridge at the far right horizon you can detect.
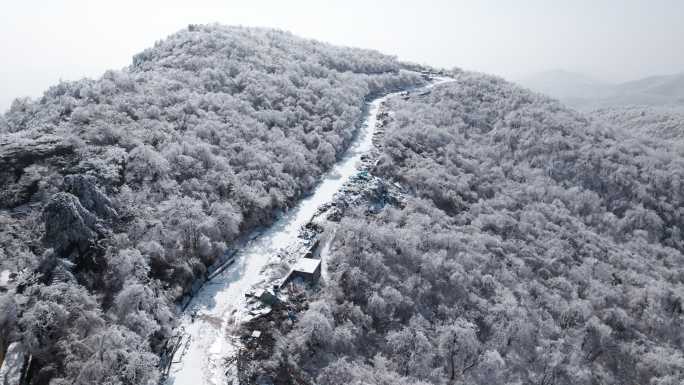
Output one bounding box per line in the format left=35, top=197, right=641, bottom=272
left=518, top=70, right=684, bottom=109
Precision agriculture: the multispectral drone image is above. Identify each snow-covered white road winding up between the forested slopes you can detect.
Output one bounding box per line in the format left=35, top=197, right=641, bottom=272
left=166, top=73, right=452, bottom=385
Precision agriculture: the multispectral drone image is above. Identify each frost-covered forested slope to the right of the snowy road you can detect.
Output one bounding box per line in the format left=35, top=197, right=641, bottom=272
left=262, top=73, right=684, bottom=385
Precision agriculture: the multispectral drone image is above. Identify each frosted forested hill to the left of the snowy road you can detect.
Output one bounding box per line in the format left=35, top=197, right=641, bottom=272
left=0, top=25, right=423, bottom=384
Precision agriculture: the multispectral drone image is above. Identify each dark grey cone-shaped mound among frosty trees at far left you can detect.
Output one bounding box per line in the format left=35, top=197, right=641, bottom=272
left=43, top=192, right=107, bottom=257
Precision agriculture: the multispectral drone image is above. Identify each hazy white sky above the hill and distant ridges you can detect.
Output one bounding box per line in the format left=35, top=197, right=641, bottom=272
left=0, top=0, right=684, bottom=111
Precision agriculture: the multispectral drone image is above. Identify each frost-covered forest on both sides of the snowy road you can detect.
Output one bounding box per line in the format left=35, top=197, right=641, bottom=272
left=0, top=25, right=684, bottom=385
